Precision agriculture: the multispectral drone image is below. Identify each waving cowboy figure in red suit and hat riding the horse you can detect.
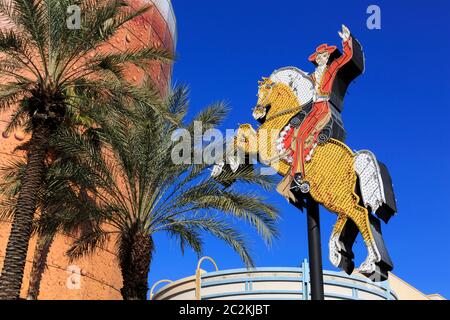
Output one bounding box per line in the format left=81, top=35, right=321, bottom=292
left=291, top=25, right=353, bottom=191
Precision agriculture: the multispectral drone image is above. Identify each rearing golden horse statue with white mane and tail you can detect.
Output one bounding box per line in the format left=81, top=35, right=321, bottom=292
left=212, top=26, right=396, bottom=281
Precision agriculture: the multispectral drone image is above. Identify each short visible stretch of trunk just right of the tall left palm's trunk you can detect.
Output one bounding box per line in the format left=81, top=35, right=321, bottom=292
left=27, top=235, right=55, bottom=300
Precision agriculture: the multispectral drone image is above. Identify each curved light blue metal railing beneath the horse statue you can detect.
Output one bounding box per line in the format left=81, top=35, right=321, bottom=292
left=152, top=257, right=398, bottom=300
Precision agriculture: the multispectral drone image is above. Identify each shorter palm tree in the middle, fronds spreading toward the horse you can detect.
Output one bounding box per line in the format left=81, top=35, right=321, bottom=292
left=41, top=87, right=277, bottom=299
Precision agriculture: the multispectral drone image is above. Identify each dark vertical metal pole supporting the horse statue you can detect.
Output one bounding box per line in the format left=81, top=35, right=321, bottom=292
left=306, top=196, right=324, bottom=300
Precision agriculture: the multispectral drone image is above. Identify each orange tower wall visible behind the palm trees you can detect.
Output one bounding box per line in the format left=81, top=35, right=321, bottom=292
left=0, top=0, right=176, bottom=299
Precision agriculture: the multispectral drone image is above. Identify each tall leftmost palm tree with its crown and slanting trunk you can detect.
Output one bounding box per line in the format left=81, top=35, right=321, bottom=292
left=0, top=0, right=171, bottom=299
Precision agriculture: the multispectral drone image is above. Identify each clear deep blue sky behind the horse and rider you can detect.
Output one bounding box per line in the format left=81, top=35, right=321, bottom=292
left=149, top=0, right=450, bottom=298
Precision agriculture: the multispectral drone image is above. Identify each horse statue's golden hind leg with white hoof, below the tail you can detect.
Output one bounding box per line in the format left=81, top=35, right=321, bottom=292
left=350, top=205, right=392, bottom=281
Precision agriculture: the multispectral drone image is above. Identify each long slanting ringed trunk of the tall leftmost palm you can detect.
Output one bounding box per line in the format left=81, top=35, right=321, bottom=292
left=0, top=124, right=50, bottom=300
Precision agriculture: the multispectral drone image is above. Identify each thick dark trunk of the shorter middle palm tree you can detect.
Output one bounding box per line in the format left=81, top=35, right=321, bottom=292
left=119, top=232, right=153, bottom=300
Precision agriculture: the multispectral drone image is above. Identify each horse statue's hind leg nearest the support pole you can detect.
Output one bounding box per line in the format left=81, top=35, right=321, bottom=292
left=329, top=214, right=358, bottom=274
